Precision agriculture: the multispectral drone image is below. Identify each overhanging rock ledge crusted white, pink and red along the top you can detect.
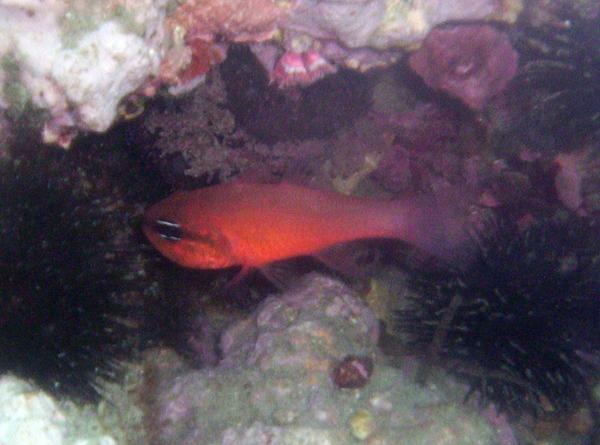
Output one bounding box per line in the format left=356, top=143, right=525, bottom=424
left=0, top=0, right=520, bottom=148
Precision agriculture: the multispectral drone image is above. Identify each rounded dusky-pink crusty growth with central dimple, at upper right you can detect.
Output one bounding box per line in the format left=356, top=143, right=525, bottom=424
left=409, top=25, right=518, bottom=110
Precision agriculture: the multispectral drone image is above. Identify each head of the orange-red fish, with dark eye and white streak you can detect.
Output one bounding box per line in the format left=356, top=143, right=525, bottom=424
left=142, top=193, right=237, bottom=269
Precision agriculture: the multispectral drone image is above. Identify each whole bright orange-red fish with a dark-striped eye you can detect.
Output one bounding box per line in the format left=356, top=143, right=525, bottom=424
left=143, top=181, right=464, bottom=277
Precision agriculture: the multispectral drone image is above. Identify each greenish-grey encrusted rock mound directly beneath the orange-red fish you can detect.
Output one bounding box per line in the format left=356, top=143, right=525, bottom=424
left=142, top=275, right=504, bottom=445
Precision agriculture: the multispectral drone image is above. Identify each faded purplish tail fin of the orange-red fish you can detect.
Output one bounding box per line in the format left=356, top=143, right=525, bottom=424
left=394, top=189, right=476, bottom=268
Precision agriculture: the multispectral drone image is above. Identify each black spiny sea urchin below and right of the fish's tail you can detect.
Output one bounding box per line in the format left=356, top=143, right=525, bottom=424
left=398, top=218, right=600, bottom=414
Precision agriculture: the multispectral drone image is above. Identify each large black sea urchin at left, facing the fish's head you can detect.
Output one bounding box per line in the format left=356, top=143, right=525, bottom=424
left=0, top=148, right=137, bottom=400
